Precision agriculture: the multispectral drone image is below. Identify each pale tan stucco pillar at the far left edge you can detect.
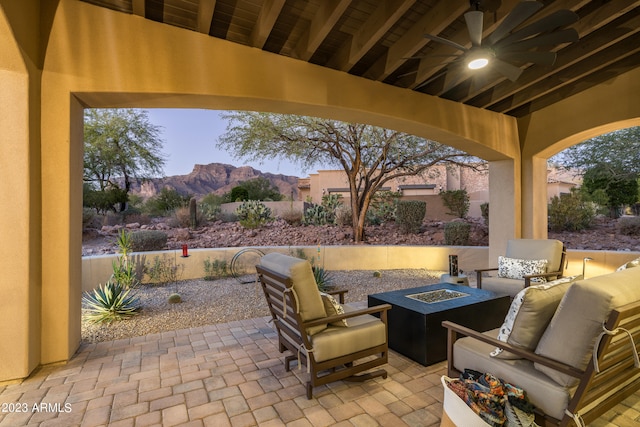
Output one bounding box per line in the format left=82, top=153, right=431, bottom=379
left=0, top=8, right=41, bottom=381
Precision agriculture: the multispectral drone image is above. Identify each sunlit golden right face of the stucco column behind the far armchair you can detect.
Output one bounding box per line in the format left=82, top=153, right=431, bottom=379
left=522, top=155, right=548, bottom=239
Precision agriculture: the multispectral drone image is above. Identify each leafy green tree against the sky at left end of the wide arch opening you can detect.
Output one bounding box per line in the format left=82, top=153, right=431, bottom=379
left=84, top=109, right=165, bottom=210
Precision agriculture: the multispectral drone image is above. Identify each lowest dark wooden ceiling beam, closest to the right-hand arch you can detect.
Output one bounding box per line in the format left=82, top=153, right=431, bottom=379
left=496, top=32, right=640, bottom=110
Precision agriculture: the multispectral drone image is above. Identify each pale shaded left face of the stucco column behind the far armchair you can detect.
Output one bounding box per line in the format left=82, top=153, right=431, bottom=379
left=487, top=160, right=522, bottom=267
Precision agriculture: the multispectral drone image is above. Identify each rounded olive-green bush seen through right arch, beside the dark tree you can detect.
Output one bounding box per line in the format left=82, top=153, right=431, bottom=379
left=548, top=189, right=596, bottom=232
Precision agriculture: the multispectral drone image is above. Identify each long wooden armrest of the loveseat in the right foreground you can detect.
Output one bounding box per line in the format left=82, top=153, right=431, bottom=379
left=442, top=320, right=585, bottom=378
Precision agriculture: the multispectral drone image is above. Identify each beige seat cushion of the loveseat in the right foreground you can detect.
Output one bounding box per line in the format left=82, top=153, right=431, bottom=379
left=453, top=329, right=570, bottom=419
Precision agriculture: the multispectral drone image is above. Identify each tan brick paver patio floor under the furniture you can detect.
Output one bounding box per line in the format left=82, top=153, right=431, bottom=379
left=0, top=318, right=640, bottom=427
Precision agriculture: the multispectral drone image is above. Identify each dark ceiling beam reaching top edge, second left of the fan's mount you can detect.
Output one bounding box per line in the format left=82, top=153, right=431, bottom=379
left=327, top=0, right=416, bottom=71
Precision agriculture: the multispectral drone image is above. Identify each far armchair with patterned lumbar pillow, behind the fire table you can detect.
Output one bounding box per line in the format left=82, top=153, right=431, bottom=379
left=476, top=239, right=566, bottom=298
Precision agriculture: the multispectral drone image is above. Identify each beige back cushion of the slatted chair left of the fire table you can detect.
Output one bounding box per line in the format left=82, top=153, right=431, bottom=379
left=260, top=253, right=327, bottom=335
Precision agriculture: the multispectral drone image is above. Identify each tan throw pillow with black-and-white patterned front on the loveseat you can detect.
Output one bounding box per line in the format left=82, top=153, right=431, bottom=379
left=490, top=276, right=582, bottom=359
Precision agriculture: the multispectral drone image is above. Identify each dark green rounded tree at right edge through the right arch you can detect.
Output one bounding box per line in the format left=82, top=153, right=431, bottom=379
left=582, top=163, right=638, bottom=218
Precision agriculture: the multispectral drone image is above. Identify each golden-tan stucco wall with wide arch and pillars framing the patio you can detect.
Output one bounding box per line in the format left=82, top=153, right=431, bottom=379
left=0, top=0, right=640, bottom=381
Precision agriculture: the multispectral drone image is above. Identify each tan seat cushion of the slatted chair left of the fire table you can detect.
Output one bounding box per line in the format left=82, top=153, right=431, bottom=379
left=311, top=304, right=387, bottom=362
